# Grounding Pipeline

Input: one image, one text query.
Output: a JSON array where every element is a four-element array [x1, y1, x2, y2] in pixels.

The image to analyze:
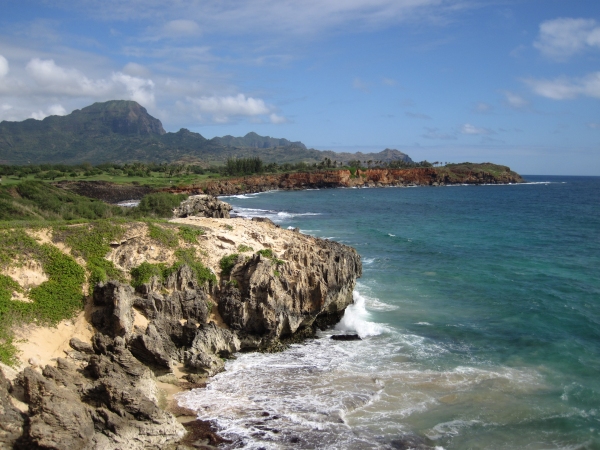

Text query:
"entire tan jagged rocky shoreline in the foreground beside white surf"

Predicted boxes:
[[0, 216, 362, 450]]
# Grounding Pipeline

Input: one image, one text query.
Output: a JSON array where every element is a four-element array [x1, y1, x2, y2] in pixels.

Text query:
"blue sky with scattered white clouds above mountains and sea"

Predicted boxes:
[[0, 0, 600, 176]]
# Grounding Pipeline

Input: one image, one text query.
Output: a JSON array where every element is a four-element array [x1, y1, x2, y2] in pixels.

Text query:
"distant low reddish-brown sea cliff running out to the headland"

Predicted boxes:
[[167, 164, 523, 195]]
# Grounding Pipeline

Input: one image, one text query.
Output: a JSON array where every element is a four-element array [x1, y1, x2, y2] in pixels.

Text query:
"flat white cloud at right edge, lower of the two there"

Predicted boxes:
[[524, 72, 600, 100]]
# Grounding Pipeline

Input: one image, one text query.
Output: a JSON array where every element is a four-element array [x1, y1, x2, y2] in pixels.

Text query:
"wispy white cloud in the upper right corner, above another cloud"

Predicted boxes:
[[533, 17, 600, 61]]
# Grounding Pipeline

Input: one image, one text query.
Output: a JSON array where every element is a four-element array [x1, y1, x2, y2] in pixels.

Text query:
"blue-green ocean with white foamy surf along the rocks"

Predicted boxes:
[[180, 176, 600, 450]]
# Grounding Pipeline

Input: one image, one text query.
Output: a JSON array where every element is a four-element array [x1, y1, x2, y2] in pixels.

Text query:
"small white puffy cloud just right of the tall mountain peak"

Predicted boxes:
[[188, 94, 278, 123]]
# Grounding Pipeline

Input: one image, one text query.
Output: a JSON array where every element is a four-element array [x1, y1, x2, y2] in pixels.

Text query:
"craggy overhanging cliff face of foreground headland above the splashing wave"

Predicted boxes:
[[219, 239, 361, 338]]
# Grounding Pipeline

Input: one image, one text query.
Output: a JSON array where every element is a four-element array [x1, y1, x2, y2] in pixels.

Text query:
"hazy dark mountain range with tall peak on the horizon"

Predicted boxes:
[[0, 100, 410, 165]]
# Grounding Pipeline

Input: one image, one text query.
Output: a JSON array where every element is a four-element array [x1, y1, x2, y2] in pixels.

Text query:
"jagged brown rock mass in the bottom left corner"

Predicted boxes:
[[8, 350, 184, 450]]
